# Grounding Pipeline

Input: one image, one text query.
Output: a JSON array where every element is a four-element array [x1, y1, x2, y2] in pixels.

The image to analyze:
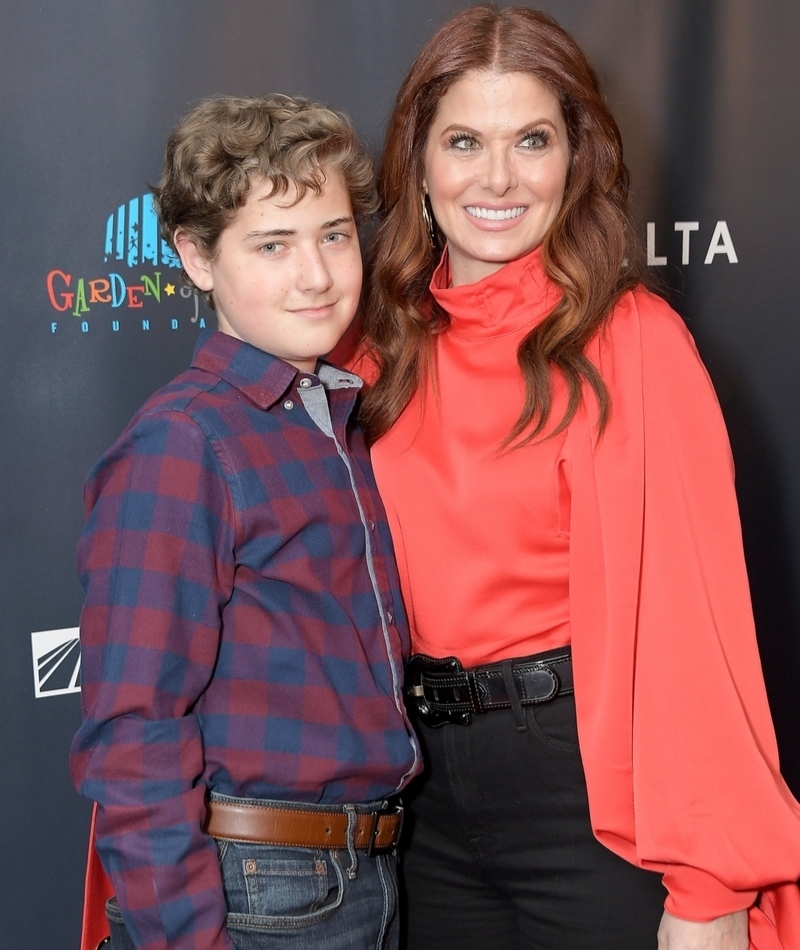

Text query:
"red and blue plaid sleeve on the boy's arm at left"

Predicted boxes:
[[71, 411, 235, 950]]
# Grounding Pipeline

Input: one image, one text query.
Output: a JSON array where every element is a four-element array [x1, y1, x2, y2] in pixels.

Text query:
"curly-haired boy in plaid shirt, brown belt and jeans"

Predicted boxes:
[[72, 96, 419, 950]]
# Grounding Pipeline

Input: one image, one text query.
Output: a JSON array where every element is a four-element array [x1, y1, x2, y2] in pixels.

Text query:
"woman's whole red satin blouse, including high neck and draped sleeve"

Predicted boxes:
[[361, 251, 800, 950]]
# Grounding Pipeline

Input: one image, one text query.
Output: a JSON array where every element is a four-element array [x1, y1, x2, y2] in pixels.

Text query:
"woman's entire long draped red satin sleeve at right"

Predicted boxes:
[[570, 291, 800, 950]]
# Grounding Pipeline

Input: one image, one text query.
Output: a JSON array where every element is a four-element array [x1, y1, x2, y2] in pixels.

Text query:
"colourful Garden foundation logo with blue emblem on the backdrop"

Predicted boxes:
[[45, 194, 206, 334]]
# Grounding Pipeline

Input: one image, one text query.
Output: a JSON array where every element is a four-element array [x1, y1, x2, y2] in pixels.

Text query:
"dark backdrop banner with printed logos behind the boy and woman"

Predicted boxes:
[[0, 0, 800, 950]]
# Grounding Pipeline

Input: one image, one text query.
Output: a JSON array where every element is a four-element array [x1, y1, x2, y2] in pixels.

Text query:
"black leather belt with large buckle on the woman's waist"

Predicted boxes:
[[406, 647, 573, 728]]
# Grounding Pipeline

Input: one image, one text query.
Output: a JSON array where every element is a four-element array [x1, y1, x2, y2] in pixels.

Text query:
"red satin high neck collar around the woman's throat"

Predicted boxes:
[[430, 247, 560, 339]]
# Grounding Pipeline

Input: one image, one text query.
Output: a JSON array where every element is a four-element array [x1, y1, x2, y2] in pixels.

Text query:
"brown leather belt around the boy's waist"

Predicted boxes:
[[205, 800, 403, 855]]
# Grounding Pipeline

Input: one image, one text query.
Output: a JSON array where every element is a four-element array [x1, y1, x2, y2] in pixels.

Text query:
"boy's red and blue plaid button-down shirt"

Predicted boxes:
[[72, 333, 419, 950]]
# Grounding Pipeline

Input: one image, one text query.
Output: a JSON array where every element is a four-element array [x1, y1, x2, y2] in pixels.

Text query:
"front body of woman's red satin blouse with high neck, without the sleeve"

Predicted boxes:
[[373, 254, 571, 666]]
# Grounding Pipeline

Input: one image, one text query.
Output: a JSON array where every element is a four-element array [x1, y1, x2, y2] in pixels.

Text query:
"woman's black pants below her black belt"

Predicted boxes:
[[401, 696, 666, 950]]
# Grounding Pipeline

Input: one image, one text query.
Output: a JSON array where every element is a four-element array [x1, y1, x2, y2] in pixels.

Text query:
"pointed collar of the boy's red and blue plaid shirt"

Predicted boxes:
[[192, 330, 362, 409]]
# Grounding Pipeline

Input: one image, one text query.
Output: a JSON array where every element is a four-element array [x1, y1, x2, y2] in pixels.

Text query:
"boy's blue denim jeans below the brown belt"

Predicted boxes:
[[107, 799, 399, 950]]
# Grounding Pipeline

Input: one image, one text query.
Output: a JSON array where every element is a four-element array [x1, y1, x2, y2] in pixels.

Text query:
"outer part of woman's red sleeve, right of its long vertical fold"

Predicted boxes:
[[633, 295, 800, 920]]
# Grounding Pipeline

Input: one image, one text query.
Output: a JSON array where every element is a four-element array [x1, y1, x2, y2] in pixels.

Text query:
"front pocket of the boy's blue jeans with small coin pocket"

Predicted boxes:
[[221, 842, 344, 930]]
